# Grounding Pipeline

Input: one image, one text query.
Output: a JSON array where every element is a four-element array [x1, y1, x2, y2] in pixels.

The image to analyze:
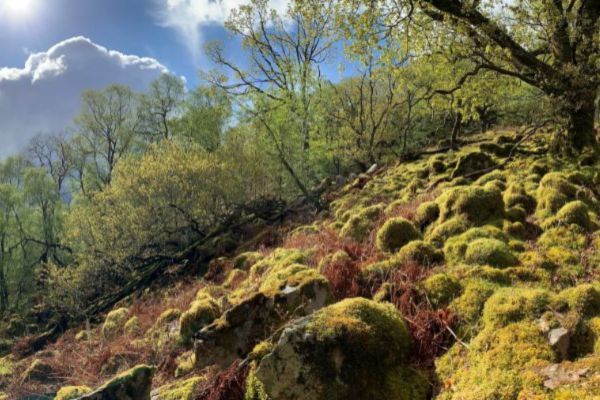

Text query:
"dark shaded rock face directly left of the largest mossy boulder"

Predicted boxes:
[[195, 279, 332, 367]]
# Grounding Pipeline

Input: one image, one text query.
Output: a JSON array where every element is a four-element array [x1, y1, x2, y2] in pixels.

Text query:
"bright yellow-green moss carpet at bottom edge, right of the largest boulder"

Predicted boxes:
[[436, 322, 555, 400]]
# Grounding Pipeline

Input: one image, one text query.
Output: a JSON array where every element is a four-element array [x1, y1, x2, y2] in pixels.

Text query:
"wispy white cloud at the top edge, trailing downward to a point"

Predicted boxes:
[[155, 0, 289, 59]]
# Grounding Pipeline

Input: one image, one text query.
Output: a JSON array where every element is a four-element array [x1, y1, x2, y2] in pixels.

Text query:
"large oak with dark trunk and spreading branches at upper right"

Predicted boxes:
[[349, 0, 600, 152]]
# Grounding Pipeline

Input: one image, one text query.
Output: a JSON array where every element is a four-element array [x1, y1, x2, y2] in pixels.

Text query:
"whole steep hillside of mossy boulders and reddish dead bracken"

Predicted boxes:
[[0, 131, 600, 400]]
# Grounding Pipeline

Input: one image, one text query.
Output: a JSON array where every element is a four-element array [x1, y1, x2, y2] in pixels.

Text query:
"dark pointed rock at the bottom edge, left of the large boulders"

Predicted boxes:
[[79, 365, 156, 400]]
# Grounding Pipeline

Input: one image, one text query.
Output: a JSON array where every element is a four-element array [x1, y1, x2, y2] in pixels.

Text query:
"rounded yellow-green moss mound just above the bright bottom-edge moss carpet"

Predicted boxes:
[[483, 288, 551, 329]]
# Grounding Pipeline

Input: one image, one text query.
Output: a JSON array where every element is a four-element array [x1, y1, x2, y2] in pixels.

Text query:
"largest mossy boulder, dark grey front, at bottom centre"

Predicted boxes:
[[255, 298, 429, 400]]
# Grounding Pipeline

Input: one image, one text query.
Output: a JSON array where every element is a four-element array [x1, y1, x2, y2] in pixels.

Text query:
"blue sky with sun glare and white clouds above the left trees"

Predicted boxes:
[[0, 0, 286, 158]]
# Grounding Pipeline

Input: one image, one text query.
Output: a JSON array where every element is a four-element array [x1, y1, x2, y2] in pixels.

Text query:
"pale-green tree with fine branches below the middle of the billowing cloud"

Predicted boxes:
[[75, 85, 139, 185]]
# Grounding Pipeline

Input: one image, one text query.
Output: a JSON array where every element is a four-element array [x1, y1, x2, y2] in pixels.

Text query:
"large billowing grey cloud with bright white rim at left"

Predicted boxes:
[[0, 37, 168, 157]]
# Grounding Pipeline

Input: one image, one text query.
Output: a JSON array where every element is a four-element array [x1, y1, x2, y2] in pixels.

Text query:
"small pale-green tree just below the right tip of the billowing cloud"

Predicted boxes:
[[139, 74, 185, 141]]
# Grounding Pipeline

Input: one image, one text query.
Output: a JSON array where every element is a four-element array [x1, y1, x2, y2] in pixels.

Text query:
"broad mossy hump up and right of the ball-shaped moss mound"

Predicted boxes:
[[437, 186, 504, 225]]
